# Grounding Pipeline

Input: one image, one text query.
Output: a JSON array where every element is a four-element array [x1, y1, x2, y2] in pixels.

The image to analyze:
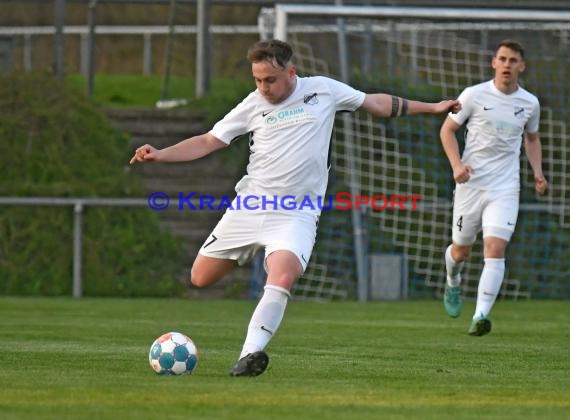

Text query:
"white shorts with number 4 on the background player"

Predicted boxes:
[[452, 184, 519, 246]]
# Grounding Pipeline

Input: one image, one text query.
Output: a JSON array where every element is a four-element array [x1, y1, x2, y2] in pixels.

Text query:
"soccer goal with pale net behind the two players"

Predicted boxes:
[[259, 6, 570, 300]]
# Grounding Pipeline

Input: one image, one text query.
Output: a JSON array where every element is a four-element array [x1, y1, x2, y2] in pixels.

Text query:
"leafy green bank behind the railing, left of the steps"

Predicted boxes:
[[0, 74, 185, 296]]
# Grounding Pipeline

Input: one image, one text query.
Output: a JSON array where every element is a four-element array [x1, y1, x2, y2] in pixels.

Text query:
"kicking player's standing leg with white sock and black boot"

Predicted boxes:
[[230, 251, 303, 376]]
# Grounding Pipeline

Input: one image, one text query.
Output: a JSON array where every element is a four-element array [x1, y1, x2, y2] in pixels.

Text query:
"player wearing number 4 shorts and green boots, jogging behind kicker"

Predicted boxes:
[[440, 40, 547, 336]]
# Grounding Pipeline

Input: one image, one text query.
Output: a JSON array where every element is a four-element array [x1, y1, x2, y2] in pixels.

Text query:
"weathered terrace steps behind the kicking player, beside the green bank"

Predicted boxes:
[[106, 109, 251, 298]]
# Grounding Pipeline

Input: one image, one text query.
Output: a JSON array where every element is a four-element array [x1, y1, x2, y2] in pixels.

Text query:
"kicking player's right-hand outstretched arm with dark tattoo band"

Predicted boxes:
[[362, 93, 461, 118]]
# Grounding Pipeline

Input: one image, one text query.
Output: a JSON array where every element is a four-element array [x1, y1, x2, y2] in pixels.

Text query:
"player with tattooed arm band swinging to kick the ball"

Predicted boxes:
[[131, 40, 460, 376]]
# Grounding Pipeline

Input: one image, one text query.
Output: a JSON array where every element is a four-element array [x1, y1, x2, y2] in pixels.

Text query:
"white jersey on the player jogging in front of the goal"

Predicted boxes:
[[449, 80, 540, 191]]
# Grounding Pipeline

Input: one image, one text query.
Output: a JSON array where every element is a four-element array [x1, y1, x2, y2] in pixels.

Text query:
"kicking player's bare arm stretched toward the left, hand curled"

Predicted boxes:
[[130, 133, 227, 165]]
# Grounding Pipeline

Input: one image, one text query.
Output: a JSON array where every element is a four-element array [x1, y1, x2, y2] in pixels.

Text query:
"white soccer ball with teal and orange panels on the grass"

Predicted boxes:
[[148, 332, 198, 375]]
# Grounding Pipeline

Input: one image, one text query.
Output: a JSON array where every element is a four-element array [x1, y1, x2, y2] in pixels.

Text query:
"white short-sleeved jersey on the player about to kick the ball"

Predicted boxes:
[[210, 76, 365, 203]]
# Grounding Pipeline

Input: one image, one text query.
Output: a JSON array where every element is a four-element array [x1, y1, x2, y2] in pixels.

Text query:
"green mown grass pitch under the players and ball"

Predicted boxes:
[[0, 297, 570, 420]]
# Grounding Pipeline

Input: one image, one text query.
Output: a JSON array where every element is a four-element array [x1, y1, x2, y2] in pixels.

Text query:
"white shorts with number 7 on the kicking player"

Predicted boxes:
[[199, 205, 318, 271]]
